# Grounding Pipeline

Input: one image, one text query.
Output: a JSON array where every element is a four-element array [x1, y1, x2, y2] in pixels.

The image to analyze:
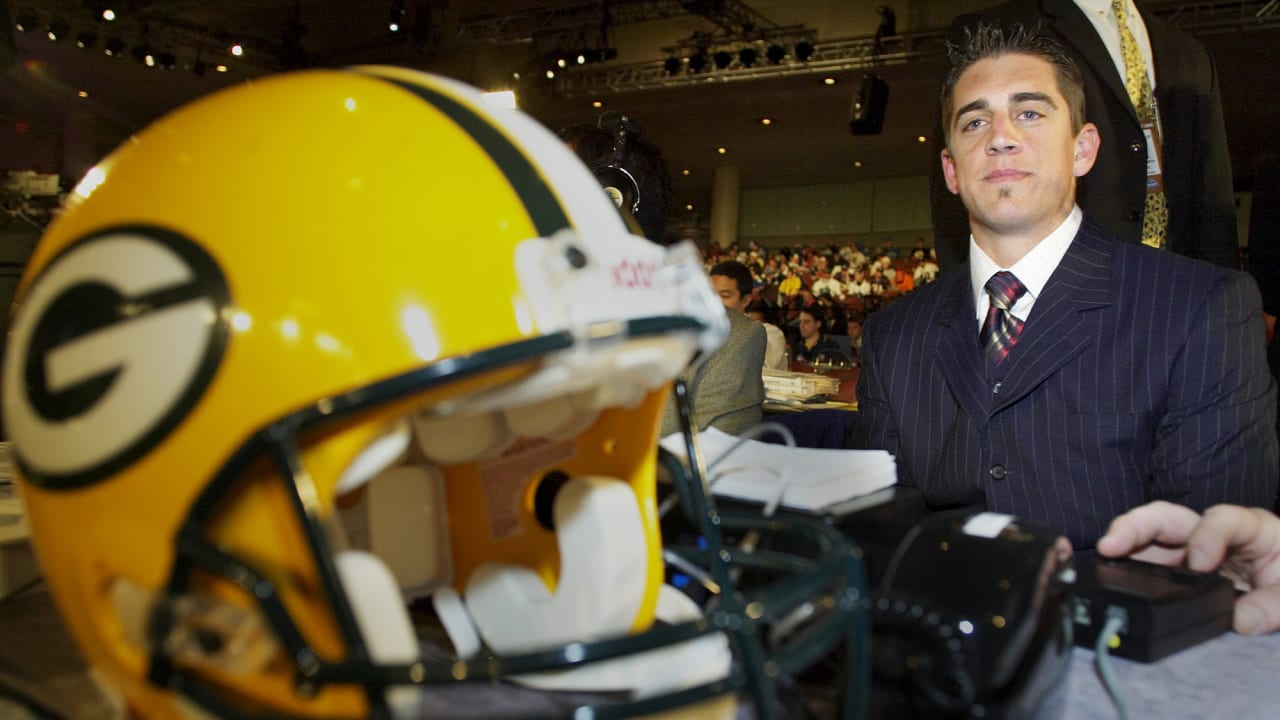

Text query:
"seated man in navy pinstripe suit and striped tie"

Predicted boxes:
[[852, 27, 1280, 551]]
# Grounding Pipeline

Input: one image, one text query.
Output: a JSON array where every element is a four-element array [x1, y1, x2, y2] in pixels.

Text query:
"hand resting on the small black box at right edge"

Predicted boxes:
[[1098, 501, 1280, 635]]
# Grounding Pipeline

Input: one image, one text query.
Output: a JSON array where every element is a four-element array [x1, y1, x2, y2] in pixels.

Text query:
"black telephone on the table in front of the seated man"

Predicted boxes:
[[872, 512, 1074, 717]]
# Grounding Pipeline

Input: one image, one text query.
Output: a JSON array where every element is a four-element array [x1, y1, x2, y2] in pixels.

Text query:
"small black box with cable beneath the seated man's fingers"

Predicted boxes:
[[1075, 559, 1235, 662]]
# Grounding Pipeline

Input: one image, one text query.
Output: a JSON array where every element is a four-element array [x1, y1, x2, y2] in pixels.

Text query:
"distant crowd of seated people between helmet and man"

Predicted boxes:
[[704, 238, 938, 366]]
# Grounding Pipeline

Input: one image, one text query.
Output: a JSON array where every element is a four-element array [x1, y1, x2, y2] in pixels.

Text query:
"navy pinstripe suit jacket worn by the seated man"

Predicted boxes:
[[852, 220, 1280, 551]]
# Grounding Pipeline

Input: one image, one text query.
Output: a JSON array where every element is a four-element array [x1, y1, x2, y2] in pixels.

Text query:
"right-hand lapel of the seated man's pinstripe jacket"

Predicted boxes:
[[991, 222, 1112, 413]]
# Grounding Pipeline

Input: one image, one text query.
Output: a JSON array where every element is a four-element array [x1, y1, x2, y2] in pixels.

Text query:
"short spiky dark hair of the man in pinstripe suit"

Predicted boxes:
[[942, 20, 1084, 147]]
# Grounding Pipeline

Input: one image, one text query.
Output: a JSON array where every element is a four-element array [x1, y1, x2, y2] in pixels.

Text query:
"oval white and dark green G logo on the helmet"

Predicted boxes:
[[3, 225, 230, 488]]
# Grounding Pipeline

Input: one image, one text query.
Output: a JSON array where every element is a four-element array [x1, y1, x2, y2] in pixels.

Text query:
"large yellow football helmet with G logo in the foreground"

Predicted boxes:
[[3, 67, 856, 717]]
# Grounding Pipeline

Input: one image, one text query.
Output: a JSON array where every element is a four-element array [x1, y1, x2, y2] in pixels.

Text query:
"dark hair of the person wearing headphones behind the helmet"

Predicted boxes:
[[559, 123, 672, 245]]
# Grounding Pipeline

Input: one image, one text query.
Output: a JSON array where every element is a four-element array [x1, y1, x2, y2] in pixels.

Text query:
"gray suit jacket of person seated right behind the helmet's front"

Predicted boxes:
[[662, 309, 765, 437]]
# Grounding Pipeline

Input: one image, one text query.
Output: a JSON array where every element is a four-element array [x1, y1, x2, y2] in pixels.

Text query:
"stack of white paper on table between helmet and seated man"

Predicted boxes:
[[662, 428, 897, 510]]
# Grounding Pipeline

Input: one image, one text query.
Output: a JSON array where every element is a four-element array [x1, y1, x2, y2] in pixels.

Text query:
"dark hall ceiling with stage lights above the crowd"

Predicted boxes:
[[0, 0, 1280, 222]]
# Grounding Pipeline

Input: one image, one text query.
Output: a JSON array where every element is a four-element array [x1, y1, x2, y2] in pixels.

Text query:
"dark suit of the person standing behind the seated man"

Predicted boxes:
[[931, 0, 1240, 270]]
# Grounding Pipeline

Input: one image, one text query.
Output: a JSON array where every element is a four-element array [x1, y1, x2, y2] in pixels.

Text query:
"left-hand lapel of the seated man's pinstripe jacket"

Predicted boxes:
[[931, 269, 988, 427]]
